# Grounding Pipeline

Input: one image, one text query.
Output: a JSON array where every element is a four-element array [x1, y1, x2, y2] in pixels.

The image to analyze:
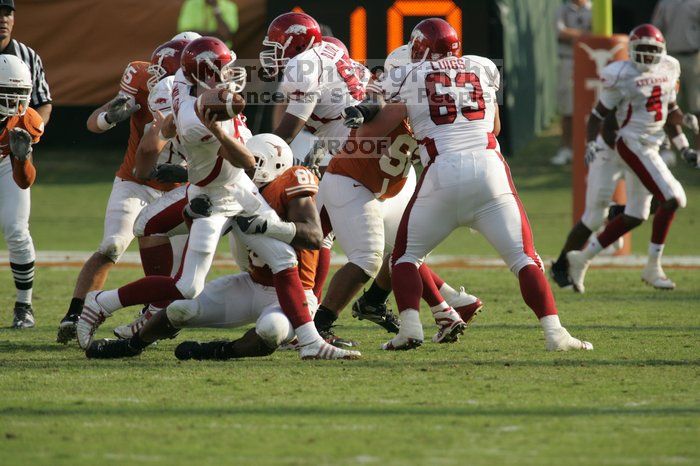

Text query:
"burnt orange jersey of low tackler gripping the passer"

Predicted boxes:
[[250, 166, 318, 290]]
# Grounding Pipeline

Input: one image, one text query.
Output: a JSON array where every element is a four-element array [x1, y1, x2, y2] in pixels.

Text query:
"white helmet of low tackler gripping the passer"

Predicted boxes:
[[246, 133, 294, 186]]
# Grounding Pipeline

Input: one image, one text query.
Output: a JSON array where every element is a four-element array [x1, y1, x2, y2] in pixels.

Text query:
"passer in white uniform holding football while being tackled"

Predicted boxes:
[[77, 37, 356, 359]]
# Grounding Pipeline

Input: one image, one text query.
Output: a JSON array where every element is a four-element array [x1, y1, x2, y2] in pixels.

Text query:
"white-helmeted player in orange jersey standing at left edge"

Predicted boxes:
[[0, 55, 44, 329]]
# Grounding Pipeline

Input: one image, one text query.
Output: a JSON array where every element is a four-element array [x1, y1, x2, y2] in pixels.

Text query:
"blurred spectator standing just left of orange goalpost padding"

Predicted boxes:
[[551, 0, 591, 165]]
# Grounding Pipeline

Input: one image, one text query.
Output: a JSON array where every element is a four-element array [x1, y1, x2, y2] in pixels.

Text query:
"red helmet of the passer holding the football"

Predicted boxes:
[[180, 37, 246, 93]]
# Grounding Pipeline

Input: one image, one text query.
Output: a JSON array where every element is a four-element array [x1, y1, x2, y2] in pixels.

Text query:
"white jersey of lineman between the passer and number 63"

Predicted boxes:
[[281, 42, 369, 153]]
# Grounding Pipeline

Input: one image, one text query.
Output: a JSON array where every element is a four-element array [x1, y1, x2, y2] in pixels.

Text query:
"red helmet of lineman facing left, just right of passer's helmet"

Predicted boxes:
[[260, 13, 321, 76]]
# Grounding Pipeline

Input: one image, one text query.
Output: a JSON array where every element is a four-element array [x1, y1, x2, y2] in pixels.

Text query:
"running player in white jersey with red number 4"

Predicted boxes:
[[566, 24, 698, 293]]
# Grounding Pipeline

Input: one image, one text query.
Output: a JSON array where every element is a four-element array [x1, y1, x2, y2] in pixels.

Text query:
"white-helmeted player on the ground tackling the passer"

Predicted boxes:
[[86, 134, 359, 360]]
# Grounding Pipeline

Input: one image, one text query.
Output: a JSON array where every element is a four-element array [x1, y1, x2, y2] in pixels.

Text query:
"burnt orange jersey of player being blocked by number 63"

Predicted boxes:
[[326, 121, 418, 199]]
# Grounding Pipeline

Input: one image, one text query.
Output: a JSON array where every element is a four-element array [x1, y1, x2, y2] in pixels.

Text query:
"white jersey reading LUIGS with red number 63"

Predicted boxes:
[[381, 55, 500, 165]]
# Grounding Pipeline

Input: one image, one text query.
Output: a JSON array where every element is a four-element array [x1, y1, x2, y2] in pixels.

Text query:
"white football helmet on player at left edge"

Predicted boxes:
[[0, 55, 32, 120]]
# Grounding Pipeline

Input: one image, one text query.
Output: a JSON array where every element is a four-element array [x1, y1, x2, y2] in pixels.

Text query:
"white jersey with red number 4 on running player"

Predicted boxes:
[[600, 55, 681, 146]]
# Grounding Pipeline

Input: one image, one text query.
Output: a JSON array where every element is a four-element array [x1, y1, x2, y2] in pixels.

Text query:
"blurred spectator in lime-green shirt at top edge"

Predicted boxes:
[[177, 0, 238, 47]]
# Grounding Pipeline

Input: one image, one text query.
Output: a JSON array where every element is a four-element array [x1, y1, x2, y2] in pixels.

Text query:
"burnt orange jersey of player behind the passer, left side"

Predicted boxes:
[[117, 61, 177, 191]]
